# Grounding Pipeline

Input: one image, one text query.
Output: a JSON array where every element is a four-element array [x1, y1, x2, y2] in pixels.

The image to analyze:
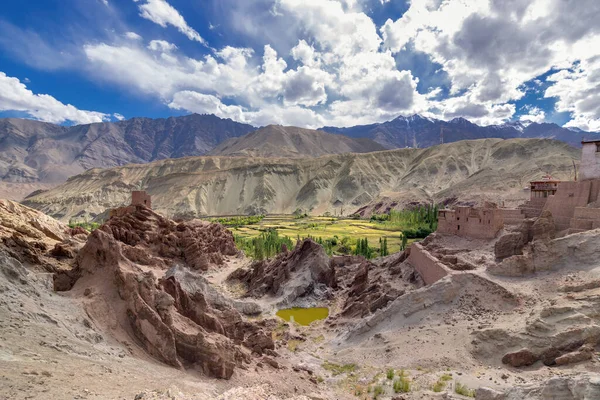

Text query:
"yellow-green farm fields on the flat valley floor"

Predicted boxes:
[[220, 215, 414, 253]]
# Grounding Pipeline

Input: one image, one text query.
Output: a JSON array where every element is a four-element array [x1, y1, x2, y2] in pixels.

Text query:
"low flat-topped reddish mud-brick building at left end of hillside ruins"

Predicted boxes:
[[437, 206, 504, 239]]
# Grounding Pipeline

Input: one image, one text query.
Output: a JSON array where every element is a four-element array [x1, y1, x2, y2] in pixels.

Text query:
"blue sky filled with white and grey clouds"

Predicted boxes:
[[0, 0, 600, 130]]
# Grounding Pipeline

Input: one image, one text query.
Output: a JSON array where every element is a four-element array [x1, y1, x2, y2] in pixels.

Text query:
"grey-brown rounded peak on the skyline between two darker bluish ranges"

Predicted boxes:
[[209, 125, 385, 157]]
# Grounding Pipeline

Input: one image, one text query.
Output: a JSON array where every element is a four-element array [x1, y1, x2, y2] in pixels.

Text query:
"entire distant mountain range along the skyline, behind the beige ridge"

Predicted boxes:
[[0, 114, 600, 199]]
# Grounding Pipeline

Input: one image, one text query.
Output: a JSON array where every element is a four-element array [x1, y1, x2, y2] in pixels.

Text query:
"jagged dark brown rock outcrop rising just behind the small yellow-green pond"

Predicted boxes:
[[228, 239, 337, 305]]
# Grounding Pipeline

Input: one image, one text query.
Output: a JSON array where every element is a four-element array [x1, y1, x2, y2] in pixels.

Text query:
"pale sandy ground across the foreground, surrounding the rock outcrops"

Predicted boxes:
[[0, 231, 600, 400]]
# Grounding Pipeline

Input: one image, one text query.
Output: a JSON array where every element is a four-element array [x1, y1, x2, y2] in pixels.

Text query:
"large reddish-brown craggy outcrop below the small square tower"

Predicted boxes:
[[73, 207, 274, 379]]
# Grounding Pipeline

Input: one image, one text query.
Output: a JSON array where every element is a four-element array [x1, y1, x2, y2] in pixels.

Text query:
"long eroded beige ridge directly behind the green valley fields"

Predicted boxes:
[[24, 139, 579, 221]]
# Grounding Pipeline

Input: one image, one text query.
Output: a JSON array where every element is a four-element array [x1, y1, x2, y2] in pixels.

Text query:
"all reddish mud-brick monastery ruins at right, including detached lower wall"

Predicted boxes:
[[408, 140, 600, 285]]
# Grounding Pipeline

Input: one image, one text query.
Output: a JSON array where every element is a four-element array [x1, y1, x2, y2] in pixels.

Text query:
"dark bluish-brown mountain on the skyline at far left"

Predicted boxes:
[[0, 114, 255, 198]]
